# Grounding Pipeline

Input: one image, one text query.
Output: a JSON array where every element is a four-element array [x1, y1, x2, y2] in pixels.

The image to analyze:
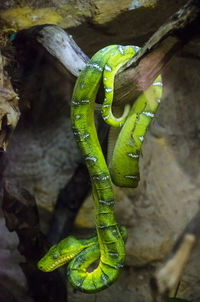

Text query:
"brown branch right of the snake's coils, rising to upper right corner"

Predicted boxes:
[[115, 0, 200, 103]]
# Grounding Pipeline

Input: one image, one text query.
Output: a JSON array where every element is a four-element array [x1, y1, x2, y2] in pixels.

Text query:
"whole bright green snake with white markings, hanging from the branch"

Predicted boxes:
[[38, 45, 162, 293]]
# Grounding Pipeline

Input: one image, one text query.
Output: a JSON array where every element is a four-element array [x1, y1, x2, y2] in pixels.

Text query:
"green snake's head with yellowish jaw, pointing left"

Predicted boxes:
[[37, 236, 84, 272]]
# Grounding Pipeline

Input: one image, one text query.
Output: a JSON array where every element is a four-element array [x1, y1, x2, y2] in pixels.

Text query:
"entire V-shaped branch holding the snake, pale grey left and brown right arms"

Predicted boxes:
[[13, 0, 200, 104]]
